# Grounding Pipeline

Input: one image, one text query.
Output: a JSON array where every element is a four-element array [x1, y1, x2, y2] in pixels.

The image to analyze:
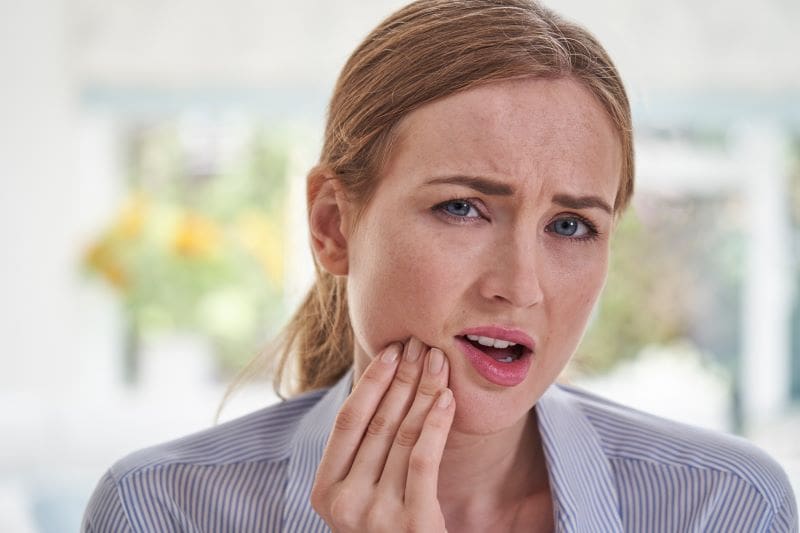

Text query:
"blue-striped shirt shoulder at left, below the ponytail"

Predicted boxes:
[[83, 389, 327, 531]]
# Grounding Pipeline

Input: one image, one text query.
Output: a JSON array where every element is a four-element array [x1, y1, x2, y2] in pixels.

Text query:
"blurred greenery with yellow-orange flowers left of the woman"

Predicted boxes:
[[84, 122, 296, 376]]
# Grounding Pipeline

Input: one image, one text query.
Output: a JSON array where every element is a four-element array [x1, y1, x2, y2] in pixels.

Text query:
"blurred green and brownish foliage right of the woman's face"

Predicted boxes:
[[575, 194, 744, 373]]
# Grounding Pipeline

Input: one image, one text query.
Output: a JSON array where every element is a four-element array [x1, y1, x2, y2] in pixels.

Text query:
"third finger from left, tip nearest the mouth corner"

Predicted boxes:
[[379, 348, 449, 499]]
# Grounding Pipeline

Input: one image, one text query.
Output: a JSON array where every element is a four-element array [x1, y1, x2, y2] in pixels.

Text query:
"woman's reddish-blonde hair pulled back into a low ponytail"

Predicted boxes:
[[234, 0, 633, 400]]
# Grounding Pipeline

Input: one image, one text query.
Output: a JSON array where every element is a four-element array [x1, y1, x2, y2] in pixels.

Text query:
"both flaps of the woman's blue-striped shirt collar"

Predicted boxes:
[[284, 370, 623, 533]]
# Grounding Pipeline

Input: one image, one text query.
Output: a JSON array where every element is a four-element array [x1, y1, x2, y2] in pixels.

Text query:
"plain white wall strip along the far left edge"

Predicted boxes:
[[0, 0, 79, 390]]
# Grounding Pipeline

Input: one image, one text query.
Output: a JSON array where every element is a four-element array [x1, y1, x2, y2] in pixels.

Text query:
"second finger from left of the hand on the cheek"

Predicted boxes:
[[348, 337, 427, 484]]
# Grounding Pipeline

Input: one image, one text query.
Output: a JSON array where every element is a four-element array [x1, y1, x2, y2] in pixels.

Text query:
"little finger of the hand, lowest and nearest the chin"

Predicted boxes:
[[405, 389, 456, 513]]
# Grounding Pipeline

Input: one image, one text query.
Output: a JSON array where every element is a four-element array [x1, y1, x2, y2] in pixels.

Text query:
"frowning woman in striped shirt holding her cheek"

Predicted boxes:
[[84, 0, 797, 532]]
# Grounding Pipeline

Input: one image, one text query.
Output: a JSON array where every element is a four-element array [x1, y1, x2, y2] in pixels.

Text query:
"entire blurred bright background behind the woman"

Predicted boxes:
[[0, 0, 800, 532]]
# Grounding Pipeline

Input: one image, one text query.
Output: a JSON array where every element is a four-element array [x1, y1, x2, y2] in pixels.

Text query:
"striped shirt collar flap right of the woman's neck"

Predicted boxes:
[[536, 385, 623, 533]]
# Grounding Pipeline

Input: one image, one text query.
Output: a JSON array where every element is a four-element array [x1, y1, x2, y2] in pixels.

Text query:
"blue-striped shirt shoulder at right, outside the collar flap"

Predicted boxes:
[[560, 386, 797, 530]]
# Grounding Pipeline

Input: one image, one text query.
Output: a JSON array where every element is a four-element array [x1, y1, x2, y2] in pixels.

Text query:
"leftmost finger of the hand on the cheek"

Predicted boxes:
[[315, 343, 402, 486]]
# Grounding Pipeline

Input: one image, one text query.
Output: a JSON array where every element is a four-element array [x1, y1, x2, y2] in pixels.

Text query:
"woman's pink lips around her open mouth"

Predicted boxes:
[[456, 326, 535, 387]]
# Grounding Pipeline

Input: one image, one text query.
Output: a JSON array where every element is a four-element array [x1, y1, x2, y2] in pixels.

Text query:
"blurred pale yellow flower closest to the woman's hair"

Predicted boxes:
[[236, 211, 283, 286]]
